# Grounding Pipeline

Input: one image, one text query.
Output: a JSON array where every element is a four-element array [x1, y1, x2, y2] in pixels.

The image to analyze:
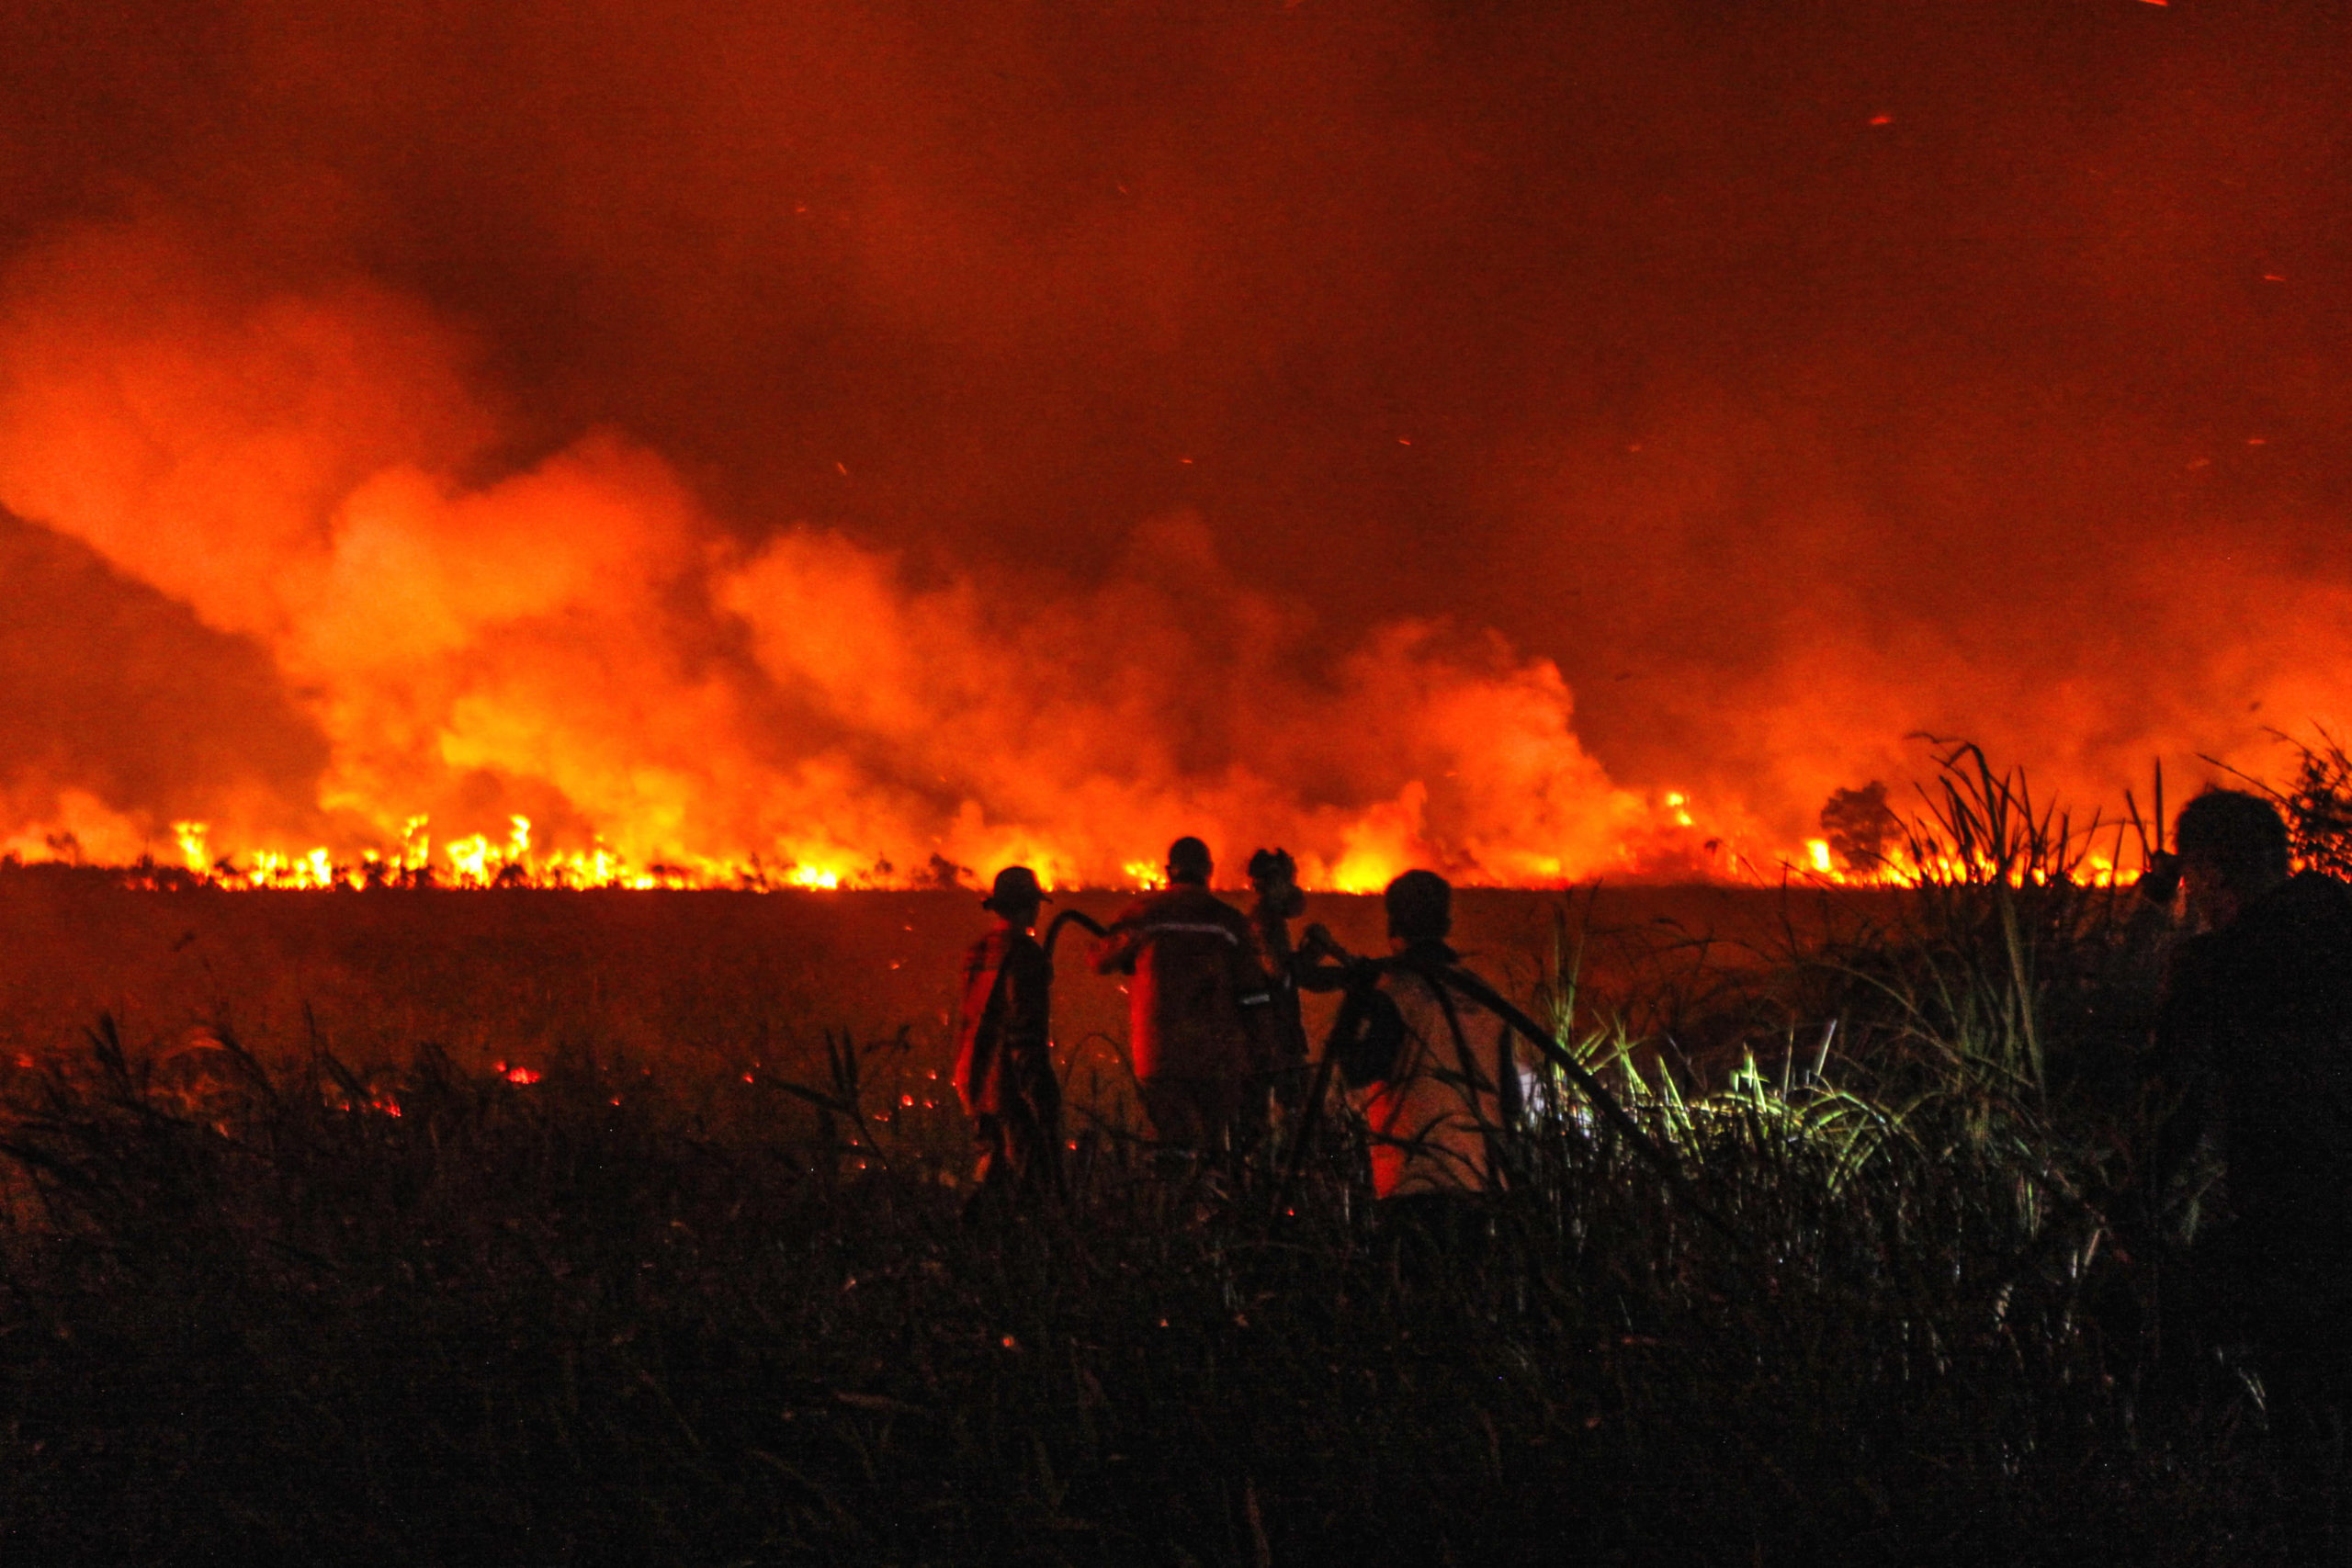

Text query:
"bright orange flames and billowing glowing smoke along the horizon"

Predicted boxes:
[[0, 231, 2352, 891]]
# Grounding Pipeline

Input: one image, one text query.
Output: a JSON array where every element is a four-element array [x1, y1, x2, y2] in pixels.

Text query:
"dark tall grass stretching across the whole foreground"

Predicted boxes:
[[0, 752, 2314, 1565]]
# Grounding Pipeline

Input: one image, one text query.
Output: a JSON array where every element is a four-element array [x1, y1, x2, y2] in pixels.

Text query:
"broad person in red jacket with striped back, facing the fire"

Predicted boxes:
[[1093, 837, 1275, 1149]]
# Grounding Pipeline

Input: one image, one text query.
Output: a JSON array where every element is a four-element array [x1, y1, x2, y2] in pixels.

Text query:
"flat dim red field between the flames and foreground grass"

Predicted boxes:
[[0, 867, 1871, 1072]]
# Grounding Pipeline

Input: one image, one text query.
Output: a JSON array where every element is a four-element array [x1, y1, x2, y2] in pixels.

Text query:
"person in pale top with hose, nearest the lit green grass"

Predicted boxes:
[[1312, 870, 1521, 1256]]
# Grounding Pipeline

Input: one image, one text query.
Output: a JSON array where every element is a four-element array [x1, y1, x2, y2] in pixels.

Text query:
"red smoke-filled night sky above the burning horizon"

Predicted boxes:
[[0, 0, 2352, 886]]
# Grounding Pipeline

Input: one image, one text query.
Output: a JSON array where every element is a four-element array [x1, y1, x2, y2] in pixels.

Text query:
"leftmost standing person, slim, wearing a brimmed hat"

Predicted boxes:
[[955, 865, 1061, 1213]]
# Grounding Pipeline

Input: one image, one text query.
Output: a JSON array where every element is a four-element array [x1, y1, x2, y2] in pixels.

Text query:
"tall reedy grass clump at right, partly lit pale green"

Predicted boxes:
[[1538, 745, 2211, 1476]]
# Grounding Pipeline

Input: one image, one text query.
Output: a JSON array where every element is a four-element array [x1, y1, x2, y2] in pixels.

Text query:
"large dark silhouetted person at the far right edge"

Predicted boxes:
[[2154, 790, 2352, 1556]]
